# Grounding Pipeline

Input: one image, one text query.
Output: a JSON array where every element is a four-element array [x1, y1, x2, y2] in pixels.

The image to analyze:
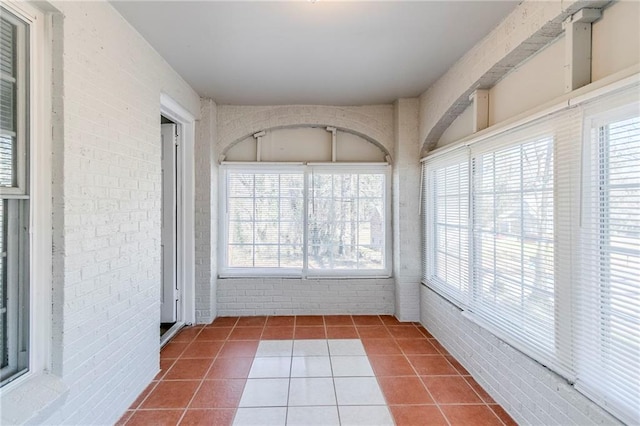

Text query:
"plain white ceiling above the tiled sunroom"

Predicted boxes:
[[112, 0, 518, 105]]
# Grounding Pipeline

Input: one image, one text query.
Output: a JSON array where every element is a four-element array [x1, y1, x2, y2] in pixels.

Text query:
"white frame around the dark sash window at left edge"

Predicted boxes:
[[0, 2, 52, 392]]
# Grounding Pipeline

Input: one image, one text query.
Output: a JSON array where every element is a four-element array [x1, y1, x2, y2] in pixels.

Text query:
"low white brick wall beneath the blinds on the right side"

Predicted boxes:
[[421, 286, 619, 426]]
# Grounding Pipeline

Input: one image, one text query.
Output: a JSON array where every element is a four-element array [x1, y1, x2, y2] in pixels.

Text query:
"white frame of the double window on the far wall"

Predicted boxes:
[[219, 162, 392, 278]]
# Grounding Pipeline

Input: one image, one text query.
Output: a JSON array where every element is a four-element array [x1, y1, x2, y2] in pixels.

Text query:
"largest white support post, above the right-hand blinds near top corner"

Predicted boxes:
[[562, 8, 602, 93]]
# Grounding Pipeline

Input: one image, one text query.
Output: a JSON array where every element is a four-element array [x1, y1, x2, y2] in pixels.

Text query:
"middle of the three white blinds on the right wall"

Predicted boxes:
[[469, 109, 581, 368]]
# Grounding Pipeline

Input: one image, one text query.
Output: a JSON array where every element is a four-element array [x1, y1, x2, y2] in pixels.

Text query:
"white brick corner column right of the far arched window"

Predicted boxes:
[[393, 98, 422, 321]]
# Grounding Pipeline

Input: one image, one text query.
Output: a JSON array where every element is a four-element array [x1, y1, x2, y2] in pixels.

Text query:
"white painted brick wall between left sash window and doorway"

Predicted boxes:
[[45, 2, 200, 424]]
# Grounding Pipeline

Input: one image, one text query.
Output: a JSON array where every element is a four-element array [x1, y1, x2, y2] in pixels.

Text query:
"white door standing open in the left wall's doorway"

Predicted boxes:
[[160, 124, 178, 323]]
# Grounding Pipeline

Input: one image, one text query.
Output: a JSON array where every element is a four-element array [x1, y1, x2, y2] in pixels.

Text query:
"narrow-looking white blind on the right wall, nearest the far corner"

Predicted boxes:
[[423, 148, 470, 305]]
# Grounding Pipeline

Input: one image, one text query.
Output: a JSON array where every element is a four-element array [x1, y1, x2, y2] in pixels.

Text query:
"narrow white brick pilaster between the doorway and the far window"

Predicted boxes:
[[195, 99, 218, 324]]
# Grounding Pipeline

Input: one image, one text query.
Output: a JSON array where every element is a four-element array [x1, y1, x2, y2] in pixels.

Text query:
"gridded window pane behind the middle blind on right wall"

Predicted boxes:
[[473, 138, 555, 352]]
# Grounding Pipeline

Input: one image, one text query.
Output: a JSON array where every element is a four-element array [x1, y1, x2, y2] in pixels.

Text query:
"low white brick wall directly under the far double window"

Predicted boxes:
[[218, 278, 395, 317]]
